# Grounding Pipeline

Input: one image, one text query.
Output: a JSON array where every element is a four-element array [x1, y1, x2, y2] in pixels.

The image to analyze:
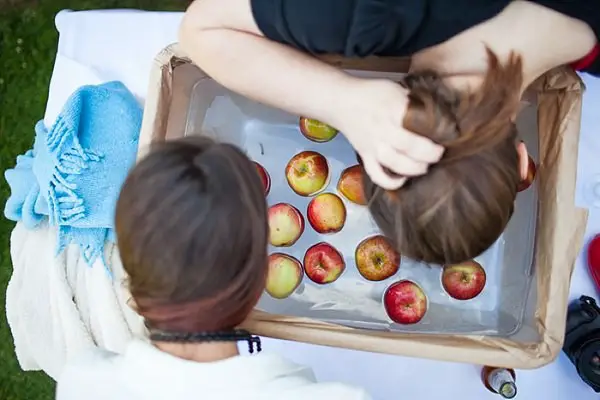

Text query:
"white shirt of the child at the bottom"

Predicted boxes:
[[56, 340, 371, 400]]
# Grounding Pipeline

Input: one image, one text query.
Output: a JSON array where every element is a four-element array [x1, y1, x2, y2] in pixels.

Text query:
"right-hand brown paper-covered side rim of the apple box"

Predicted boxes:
[[532, 68, 588, 363]]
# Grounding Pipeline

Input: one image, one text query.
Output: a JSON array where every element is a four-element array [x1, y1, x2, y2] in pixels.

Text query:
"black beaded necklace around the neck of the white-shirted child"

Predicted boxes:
[[150, 329, 262, 354]]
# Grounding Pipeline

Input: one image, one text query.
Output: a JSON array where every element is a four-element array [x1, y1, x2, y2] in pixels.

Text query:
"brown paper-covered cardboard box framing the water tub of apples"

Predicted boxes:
[[139, 44, 587, 369]]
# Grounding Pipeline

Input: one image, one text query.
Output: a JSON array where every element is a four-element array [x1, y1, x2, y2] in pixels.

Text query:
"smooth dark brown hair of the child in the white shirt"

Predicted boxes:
[[116, 136, 268, 333]]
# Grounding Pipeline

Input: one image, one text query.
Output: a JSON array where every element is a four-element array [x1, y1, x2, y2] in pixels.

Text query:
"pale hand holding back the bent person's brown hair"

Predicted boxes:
[[331, 79, 444, 190]]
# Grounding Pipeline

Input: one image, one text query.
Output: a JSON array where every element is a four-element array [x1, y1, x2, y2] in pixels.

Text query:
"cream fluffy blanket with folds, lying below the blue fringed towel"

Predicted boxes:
[[6, 223, 145, 379]]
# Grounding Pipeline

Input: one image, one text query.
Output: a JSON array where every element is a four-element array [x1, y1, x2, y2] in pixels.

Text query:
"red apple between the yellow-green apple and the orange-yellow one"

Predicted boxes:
[[304, 242, 346, 285]]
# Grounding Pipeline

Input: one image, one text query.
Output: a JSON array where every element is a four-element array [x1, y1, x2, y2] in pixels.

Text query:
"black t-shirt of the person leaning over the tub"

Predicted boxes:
[[251, 0, 600, 76]]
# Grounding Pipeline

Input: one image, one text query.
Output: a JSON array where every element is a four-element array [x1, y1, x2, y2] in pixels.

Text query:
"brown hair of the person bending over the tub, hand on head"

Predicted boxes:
[[365, 50, 523, 265]]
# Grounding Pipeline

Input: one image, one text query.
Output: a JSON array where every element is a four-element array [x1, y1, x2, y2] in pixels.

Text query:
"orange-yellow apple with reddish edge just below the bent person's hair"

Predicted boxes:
[[354, 235, 400, 281]]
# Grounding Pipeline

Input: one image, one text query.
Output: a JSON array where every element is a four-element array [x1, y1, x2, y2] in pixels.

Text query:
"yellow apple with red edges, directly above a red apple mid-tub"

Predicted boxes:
[[306, 193, 346, 233]]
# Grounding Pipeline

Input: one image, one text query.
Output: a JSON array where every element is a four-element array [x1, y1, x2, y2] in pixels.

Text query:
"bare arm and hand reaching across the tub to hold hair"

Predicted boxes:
[[179, 0, 443, 189]]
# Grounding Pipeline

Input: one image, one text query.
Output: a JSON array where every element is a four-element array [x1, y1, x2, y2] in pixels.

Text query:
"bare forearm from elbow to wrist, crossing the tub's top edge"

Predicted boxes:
[[180, 1, 358, 126]]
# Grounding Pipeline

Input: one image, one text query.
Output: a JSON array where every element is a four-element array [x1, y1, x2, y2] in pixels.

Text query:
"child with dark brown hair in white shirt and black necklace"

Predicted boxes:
[[57, 137, 370, 400]]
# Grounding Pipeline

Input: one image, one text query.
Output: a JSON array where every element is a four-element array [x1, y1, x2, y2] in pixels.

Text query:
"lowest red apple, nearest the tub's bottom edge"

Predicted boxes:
[[383, 280, 427, 325]]
